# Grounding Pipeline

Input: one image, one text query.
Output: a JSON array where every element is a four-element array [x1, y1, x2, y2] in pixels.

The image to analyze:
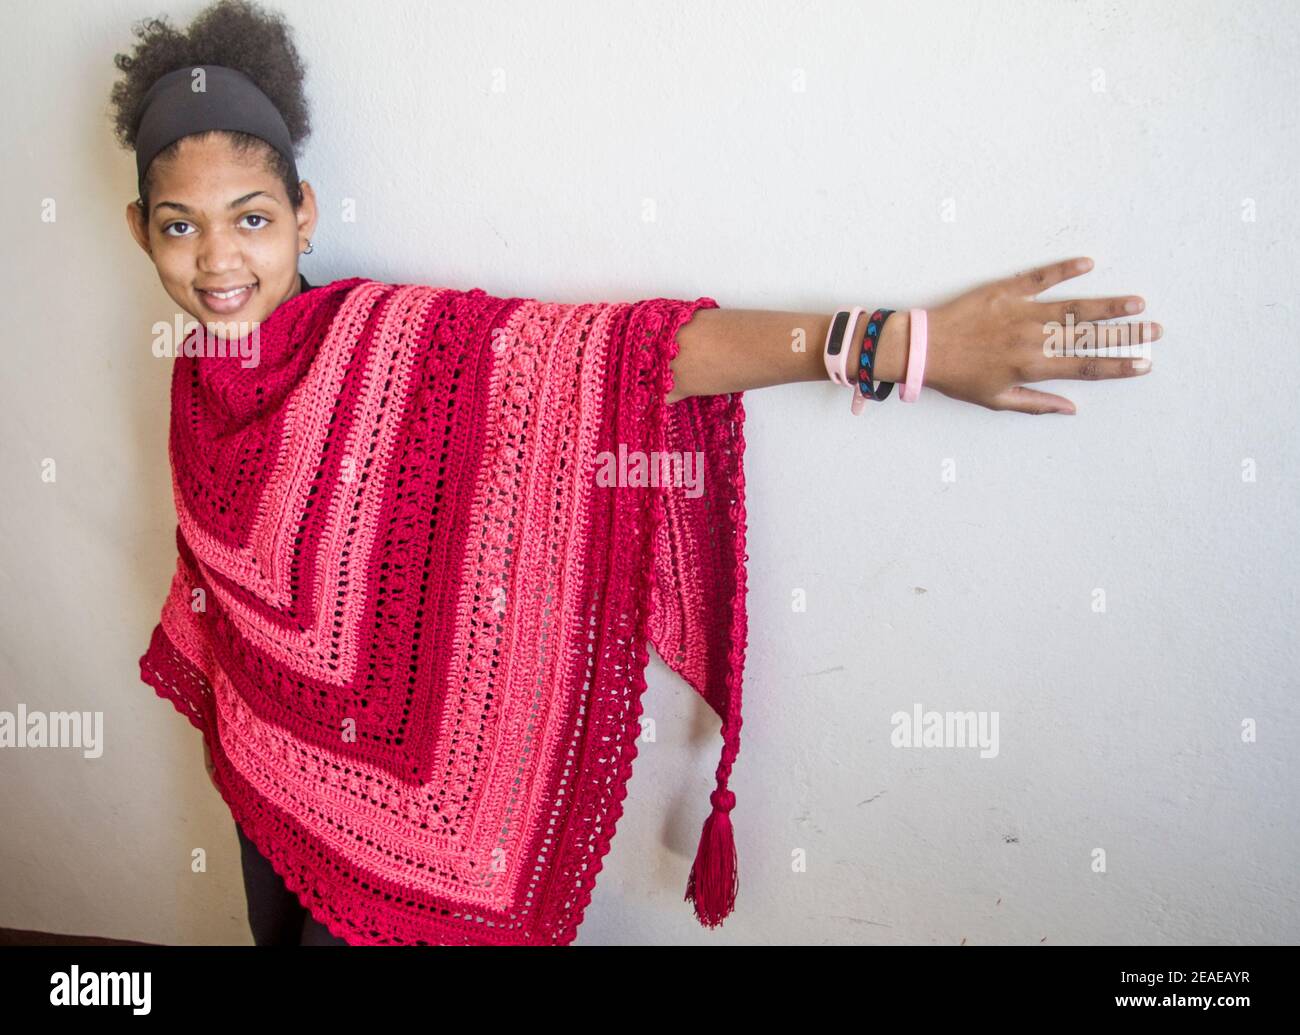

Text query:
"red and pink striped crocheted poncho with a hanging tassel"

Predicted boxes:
[[140, 277, 748, 945]]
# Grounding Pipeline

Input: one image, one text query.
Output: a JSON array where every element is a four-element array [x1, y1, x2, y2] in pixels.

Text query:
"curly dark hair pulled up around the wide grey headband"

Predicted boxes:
[[111, 0, 312, 218]]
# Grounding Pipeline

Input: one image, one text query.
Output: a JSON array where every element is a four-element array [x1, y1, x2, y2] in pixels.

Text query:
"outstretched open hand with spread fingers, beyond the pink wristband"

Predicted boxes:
[[915, 257, 1164, 413]]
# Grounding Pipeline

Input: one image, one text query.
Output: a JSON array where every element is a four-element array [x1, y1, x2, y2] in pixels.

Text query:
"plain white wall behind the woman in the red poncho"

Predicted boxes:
[[0, 0, 1300, 944]]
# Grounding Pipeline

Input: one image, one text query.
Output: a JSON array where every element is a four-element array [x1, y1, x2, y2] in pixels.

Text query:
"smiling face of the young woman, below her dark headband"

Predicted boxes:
[[126, 133, 316, 337]]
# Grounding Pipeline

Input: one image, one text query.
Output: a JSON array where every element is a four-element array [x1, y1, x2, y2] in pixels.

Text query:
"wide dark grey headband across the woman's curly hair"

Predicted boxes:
[[135, 65, 298, 198]]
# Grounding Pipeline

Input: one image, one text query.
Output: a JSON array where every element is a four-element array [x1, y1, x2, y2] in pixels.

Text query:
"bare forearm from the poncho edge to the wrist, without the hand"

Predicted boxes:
[[668, 309, 907, 403]]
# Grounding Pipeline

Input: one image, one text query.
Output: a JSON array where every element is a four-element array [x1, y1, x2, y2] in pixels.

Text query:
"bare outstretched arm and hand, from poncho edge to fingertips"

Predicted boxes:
[[667, 259, 1162, 413]]
